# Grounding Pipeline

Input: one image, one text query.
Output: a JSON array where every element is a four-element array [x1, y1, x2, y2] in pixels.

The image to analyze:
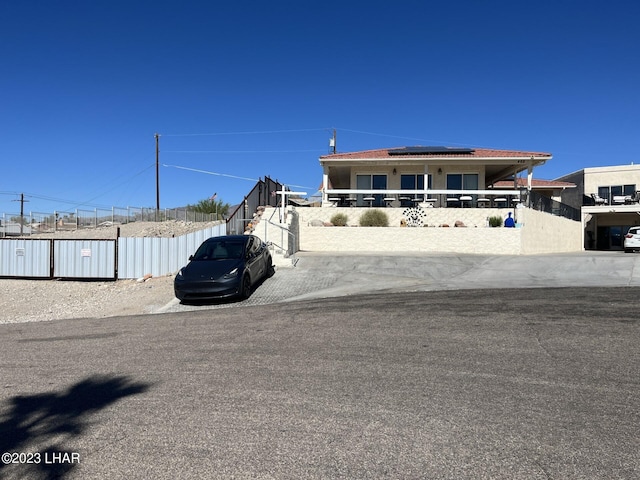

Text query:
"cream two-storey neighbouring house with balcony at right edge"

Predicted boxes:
[[556, 164, 640, 250]]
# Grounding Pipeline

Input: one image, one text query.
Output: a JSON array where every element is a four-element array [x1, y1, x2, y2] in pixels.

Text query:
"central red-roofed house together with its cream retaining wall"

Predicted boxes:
[[251, 146, 583, 255]]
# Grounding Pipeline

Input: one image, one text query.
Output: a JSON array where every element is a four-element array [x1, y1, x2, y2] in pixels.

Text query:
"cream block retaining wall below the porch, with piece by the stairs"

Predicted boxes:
[[254, 208, 582, 255]]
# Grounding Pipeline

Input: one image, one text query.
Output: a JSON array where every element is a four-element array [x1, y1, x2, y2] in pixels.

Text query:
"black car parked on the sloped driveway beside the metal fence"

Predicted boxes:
[[173, 235, 274, 302]]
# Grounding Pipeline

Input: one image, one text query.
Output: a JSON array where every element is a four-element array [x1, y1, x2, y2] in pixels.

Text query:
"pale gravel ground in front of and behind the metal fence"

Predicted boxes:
[[0, 221, 215, 323]]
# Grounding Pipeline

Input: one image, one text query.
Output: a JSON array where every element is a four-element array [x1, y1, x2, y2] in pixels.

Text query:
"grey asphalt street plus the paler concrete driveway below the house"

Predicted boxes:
[[0, 254, 640, 479]]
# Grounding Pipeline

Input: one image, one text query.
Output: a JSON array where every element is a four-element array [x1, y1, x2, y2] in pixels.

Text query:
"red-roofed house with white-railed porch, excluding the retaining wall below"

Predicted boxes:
[[320, 146, 552, 208]]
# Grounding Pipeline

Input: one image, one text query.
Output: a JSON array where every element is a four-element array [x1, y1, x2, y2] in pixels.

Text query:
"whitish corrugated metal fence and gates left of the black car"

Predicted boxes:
[[0, 224, 226, 280]]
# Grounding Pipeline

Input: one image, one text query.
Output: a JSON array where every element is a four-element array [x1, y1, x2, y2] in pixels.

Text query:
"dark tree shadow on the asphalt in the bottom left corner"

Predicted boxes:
[[0, 375, 151, 479]]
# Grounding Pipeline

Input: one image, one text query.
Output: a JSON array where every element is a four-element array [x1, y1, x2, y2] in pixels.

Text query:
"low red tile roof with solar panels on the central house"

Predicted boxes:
[[320, 147, 551, 161]]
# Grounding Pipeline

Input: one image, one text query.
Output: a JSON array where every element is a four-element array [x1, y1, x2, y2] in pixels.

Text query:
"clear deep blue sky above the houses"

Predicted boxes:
[[0, 0, 640, 213]]
